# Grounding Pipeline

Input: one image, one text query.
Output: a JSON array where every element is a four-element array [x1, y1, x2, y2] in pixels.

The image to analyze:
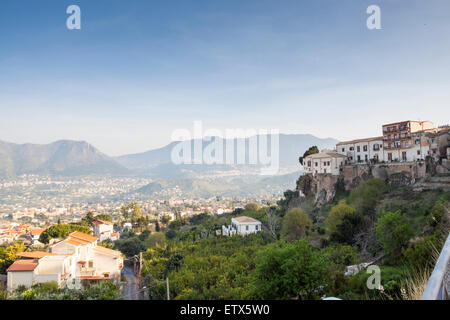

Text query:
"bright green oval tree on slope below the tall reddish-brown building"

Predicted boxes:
[[375, 211, 414, 259]]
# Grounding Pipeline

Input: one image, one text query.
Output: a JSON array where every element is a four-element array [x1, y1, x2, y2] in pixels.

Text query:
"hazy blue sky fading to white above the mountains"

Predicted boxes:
[[0, 0, 450, 155]]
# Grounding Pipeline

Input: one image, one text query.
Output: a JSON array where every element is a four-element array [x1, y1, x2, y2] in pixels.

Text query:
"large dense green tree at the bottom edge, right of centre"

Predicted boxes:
[[254, 239, 329, 300]]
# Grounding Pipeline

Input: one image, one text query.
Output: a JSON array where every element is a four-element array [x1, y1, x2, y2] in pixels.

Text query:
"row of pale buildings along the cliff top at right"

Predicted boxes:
[[303, 121, 450, 175]]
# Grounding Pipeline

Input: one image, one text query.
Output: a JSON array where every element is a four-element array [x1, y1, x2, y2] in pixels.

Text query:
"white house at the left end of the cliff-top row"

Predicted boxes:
[[303, 150, 347, 175]]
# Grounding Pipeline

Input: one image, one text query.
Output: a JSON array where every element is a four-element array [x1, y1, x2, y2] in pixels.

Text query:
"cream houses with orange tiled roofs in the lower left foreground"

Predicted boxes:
[[7, 231, 123, 290]]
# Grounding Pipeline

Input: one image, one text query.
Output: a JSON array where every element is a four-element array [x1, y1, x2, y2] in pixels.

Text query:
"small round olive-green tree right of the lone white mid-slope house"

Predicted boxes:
[[281, 208, 313, 241]]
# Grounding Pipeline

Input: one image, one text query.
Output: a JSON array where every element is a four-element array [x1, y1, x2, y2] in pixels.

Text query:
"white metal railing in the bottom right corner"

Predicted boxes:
[[422, 235, 450, 300]]
